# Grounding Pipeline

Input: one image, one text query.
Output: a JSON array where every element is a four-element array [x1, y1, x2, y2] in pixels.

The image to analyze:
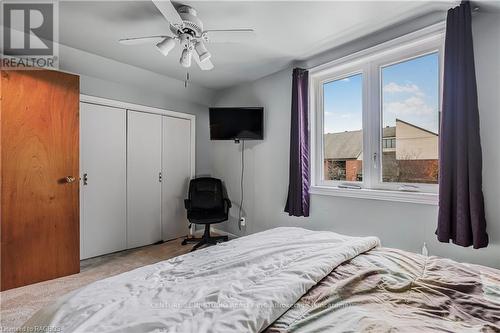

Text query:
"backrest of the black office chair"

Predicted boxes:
[[189, 177, 224, 210]]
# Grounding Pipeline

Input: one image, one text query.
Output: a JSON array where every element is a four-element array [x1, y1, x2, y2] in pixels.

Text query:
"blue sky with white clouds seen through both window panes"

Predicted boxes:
[[323, 53, 439, 133]]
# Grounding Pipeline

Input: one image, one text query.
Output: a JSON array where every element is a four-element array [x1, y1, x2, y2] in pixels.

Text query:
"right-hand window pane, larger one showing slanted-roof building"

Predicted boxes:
[[382, 53, 439, 184]]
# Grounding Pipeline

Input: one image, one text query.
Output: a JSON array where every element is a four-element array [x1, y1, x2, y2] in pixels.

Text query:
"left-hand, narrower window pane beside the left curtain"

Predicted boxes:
[[323, 74, 363, 181]]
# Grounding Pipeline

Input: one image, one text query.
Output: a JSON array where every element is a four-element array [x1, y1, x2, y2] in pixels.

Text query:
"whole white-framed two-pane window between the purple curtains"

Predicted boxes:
[[310, 30, 443, 204]]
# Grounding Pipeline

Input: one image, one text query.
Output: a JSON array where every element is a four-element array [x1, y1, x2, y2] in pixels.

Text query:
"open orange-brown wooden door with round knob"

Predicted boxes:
[[0, 70, 80, 290]]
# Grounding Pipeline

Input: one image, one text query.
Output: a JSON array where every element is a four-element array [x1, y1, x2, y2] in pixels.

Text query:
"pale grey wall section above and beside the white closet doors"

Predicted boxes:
[[59, 45, 215, 175]]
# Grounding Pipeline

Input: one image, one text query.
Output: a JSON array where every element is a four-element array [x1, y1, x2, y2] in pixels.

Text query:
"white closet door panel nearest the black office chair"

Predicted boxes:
[[162, 117, 192, 240]]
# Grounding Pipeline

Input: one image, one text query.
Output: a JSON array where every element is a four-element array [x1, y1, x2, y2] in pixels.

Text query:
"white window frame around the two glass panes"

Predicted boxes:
[[309, 24, 444, 205]]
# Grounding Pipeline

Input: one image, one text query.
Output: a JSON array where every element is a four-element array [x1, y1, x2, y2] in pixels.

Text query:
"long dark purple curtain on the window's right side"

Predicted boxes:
[[436, 2, 488, 249]]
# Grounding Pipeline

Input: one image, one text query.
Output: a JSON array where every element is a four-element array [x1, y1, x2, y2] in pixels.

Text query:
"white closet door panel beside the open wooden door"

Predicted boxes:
[[80, 103, 127, 259]]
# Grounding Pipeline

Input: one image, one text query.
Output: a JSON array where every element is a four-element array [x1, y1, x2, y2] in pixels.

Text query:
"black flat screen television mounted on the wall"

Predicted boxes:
[[210, 107, 264, 140]]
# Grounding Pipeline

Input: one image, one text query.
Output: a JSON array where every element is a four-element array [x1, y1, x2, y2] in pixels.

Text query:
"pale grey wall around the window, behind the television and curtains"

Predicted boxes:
[[211, 12, 500, 268]]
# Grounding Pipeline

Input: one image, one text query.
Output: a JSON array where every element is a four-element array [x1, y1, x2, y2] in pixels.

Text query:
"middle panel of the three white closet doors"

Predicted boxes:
[[127, 111, 162, 248]]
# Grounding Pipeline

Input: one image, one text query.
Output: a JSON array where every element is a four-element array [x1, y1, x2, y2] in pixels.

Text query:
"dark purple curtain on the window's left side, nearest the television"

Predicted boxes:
[[285, 68, 309, 216]]
